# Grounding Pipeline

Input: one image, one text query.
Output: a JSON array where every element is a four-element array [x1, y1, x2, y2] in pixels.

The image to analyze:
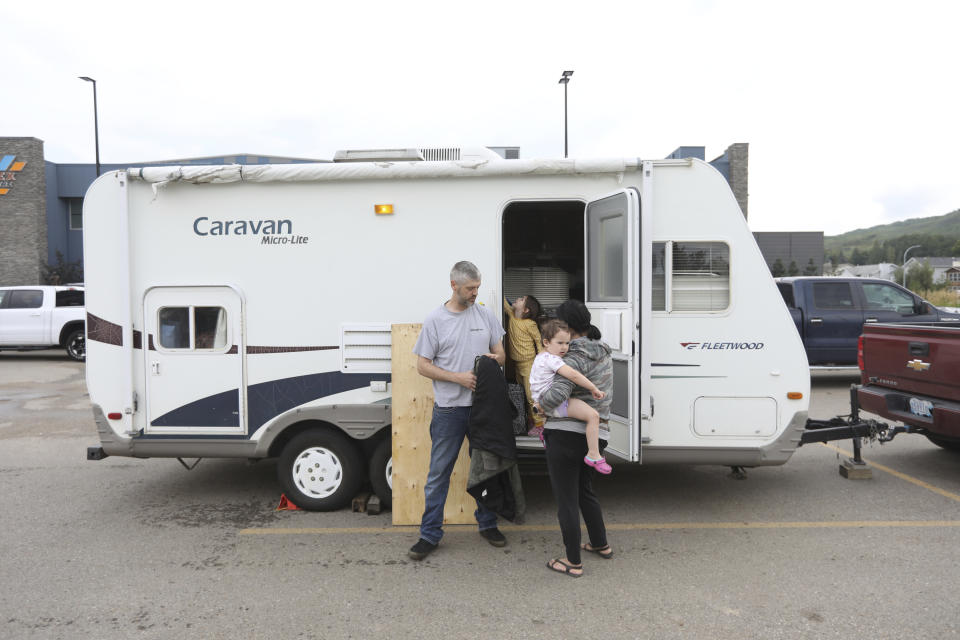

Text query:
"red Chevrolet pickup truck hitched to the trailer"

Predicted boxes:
[[857, 324, 960, 451]]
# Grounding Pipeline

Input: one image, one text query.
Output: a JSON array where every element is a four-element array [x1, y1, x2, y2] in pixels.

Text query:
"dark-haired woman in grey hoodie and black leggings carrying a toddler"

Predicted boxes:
[[539, 300, 613, 578]]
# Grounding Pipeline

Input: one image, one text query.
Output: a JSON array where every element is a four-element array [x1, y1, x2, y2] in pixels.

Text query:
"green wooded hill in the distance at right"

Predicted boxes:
[[823, 209, 960, 264]]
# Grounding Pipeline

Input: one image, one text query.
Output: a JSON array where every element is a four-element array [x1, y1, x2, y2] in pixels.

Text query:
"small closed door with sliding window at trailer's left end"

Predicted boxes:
[[143, 286, 246, 435]]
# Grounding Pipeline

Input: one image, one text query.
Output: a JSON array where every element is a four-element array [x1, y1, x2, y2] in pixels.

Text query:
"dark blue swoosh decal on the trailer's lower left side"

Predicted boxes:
[[143, 371, 391, 438]]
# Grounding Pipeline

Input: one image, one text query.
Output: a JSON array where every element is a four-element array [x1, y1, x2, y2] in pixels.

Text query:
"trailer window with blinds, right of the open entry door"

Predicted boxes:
[[652, 241, 730, 312]]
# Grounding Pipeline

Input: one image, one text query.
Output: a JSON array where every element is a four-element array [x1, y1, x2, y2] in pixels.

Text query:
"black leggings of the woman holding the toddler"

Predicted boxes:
[[543, 429, 607, 564]]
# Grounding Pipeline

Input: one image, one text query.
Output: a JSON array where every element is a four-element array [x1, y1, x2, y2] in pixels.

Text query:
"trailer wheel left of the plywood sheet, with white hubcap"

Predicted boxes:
[[277, 429, 363, 511]]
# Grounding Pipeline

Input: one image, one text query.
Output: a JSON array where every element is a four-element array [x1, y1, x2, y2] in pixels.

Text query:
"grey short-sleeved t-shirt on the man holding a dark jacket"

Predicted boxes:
[[413, 304, 504, 407]]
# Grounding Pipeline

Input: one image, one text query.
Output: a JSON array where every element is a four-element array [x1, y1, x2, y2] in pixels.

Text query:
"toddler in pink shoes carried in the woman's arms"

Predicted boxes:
[[530, 319, 613, 475]]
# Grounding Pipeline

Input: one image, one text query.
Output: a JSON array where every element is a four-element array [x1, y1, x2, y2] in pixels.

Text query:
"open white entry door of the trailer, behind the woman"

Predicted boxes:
[[585, 189, 641, 461]]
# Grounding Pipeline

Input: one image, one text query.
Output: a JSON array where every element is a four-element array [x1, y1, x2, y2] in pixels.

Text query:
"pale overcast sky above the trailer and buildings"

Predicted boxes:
[[7, 0, 960, 235]]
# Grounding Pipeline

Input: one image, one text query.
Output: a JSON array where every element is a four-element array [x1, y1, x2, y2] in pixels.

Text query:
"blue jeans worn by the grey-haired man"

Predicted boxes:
[[420, 405, 497, 544]]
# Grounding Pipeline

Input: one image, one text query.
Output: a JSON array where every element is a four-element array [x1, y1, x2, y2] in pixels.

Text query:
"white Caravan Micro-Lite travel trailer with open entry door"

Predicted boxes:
[[83, 153, 810, 510]]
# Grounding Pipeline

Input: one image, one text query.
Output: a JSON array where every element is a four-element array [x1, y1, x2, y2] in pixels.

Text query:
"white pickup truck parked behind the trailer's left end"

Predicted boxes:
[[0, 286, 87, 362]]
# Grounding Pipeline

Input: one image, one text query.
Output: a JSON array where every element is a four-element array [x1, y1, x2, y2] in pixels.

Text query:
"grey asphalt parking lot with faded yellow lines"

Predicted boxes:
[[0, 351, 960, 639]]
